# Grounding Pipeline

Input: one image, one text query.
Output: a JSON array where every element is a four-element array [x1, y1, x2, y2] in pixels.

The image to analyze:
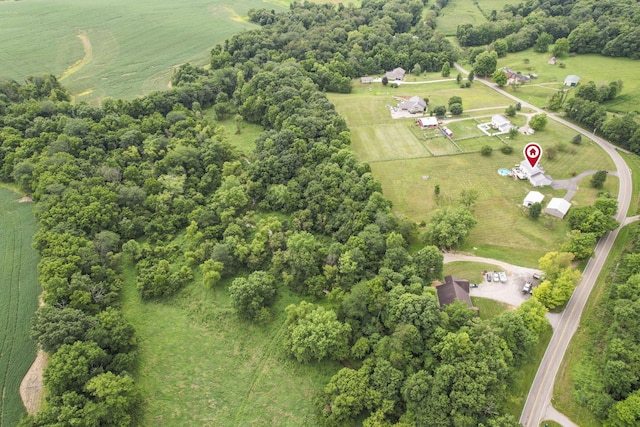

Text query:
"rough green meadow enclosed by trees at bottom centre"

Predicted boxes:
[[123, 261, 341, 426]]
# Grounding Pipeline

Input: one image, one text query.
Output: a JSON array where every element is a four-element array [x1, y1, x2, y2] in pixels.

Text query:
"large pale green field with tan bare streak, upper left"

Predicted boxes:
[[0, 0, 284, 102]]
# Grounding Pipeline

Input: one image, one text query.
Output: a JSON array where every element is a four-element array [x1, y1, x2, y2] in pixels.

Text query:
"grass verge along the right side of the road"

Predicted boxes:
[[553, 223, 638, 427]]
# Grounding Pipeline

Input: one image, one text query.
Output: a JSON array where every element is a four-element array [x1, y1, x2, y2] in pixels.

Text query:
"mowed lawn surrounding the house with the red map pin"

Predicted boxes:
[[329, 82, 618, 267]]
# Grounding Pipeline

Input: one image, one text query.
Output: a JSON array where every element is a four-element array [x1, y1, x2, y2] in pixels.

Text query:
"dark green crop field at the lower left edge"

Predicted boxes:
[[0, 187, 40, 427]]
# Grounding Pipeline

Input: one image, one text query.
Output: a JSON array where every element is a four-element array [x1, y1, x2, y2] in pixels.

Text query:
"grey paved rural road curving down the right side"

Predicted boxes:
[[455, 64, 632, 427]]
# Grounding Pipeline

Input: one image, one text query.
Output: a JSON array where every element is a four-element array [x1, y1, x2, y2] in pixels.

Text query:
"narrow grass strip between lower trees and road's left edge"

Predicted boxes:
[[504, 325, 556, 420]]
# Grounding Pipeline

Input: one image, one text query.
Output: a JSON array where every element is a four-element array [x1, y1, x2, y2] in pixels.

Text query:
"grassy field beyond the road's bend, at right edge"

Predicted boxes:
[[498, 49, 640, 112]]
